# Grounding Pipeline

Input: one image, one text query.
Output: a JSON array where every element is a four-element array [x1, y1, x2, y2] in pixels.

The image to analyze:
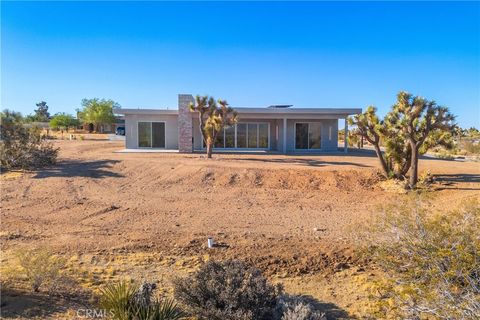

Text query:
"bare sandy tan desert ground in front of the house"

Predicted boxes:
[[0, 140, 480, 319]]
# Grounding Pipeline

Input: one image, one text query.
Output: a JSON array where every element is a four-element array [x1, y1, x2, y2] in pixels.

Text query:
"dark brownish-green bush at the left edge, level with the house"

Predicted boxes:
[[0, 110, 58, 169]]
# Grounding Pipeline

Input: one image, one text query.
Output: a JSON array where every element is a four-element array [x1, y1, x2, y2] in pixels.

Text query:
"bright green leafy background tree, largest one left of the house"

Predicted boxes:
[[78, 98, 120, 132]]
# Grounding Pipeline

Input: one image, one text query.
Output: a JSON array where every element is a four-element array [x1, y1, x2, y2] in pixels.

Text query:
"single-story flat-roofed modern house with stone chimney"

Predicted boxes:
[[114, 94, 362, 154]]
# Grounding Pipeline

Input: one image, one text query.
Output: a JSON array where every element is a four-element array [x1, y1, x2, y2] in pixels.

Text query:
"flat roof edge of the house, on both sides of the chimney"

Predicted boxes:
[[113, 107, 362, 116]]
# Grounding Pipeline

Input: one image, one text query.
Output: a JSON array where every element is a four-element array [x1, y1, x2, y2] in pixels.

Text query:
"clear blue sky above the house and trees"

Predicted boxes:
[[1, 1, 480, 127]]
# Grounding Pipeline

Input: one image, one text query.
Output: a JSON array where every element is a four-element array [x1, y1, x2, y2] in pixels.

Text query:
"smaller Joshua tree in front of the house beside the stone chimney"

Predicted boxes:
[[190, 96, 237, 158]]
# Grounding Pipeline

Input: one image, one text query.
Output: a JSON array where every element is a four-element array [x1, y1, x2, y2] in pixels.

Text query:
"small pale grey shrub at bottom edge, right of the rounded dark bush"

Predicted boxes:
[[276, 295, 327, 320]]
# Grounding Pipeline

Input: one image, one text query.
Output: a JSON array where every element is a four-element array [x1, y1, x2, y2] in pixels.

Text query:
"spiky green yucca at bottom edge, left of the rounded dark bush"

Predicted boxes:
[[100, 281, 183, 320]]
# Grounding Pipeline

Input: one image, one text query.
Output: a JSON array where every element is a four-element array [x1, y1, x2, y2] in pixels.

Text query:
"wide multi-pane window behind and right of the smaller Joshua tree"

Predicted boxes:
[[207, 123, 270, 149]]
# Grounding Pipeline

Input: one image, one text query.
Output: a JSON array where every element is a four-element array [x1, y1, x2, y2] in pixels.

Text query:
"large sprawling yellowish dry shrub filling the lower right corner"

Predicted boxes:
[[368, 201, 480, 319]]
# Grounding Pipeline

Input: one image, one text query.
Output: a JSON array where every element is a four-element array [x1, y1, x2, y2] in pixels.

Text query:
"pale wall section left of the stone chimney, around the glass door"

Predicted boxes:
[[125, 114, 178, 149]]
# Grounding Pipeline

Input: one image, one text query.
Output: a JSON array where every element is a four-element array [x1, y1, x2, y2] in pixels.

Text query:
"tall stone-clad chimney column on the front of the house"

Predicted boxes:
[[178, 94, 195, 153]]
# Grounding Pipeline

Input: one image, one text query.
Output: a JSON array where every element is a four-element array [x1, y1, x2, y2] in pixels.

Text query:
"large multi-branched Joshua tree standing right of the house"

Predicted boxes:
[[349, 91, 455, 188]]
